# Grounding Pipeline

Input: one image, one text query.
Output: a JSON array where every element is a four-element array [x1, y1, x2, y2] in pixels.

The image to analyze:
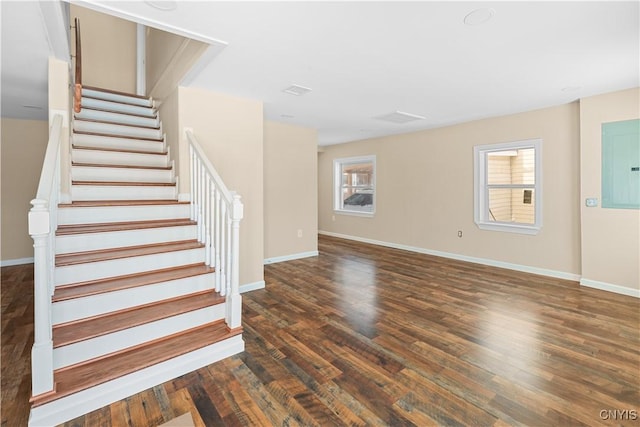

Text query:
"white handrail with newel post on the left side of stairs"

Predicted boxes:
[[29, 114, 63, 396]]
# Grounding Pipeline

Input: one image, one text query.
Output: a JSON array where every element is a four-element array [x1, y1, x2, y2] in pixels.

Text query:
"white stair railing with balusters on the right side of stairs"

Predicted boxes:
[[185, 129, 243, 329]]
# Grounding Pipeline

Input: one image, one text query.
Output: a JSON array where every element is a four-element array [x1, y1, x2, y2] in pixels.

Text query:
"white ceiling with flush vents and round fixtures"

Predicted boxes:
[[2, 1, 640, 145]]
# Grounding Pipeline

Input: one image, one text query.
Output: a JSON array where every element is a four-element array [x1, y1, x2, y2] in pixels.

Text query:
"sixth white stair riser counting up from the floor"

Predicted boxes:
[[58, 204, 191, 225]]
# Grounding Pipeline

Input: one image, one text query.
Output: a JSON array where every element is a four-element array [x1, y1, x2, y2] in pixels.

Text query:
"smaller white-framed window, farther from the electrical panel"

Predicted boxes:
[[333, 156, 376, 216]]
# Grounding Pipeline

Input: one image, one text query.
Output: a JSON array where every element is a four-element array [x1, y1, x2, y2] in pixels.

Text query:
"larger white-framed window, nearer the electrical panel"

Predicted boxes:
[[473, 139, 542, 234]]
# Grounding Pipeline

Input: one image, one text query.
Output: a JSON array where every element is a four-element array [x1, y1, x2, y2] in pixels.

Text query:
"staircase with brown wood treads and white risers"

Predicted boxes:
[[30, 87, 244, 426]]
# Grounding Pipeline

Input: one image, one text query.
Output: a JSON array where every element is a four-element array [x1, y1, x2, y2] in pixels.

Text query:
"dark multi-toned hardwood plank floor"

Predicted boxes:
[[2, 236, 640, 427]]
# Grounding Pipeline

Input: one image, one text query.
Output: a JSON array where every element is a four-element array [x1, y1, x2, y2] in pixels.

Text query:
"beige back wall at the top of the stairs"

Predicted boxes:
[[70, 4, 136, 93]]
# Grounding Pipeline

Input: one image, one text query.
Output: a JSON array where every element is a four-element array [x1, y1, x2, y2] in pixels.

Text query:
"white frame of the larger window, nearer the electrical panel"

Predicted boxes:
[[473, 139, 543, 234]]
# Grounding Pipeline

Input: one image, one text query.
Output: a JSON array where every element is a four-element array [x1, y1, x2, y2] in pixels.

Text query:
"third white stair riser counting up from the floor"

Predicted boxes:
[[51, 273, 215, 325]]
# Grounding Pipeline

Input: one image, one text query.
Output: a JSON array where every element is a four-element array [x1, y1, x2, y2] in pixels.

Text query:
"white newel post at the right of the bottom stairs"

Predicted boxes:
[[227, 193, 244, 329]]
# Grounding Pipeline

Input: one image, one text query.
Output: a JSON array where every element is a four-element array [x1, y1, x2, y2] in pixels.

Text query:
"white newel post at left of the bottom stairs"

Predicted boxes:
[[29, 199, 53, 396]]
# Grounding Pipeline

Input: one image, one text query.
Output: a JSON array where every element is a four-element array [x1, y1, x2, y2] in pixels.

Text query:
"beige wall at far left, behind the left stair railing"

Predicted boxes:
[[0, 119, 49, 262]]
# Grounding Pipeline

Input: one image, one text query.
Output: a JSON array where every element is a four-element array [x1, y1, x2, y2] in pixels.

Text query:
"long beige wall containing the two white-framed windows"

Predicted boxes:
[[318, 103, 580, 277]]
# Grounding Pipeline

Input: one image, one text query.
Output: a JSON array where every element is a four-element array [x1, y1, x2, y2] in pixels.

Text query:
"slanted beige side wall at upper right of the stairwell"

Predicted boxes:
[[145, 27, 208, 100]]
